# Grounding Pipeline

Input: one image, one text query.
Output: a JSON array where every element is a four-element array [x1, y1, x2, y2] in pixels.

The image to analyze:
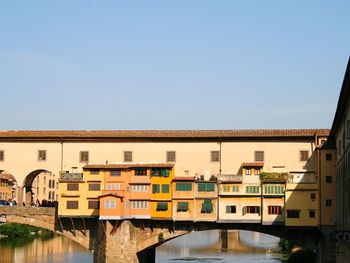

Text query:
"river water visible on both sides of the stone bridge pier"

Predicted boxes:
[[0, 230, 281, 263]]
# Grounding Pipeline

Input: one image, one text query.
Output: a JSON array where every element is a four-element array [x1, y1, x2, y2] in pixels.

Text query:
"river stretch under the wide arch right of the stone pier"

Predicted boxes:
[[156, 230, 282, 263]]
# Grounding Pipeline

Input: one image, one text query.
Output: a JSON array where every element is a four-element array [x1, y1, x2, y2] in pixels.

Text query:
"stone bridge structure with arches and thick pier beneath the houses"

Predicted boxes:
[[0, 207, 321, 263]]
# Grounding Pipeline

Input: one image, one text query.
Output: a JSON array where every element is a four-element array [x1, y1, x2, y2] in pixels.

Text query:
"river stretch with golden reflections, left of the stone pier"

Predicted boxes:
[[0, 236, 92, 263]]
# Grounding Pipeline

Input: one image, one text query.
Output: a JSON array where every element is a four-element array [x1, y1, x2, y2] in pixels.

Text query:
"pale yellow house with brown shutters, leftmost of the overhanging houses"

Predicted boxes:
[[58, 168, 104, 217]]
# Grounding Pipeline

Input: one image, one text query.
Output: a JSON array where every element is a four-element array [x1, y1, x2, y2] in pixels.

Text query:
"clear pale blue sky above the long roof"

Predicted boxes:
[[0, 0, 350, 130]]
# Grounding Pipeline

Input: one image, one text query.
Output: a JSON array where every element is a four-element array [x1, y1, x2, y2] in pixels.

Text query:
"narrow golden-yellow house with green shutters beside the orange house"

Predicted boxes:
[[151, 164, 174, 220]]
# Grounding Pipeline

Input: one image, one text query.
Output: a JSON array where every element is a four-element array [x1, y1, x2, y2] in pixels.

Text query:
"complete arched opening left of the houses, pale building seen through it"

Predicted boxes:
[[23, 169, 57, 206]]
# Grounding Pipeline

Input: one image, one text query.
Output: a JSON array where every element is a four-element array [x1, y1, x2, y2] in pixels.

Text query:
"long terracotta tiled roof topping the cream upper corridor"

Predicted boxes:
[[0, 129, 329, 140]]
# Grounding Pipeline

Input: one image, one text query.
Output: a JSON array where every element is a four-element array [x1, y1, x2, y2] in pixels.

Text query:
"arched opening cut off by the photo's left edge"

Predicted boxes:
[[0, 170, 17, 205]]
